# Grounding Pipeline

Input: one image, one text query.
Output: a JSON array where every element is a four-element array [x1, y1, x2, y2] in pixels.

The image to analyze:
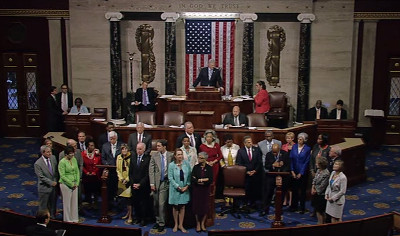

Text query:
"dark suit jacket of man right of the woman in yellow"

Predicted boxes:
[[129, 153, 151, 192]]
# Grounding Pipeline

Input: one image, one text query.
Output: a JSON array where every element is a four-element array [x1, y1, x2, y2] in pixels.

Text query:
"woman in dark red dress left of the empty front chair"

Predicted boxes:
[[200, 129, 223, 186]]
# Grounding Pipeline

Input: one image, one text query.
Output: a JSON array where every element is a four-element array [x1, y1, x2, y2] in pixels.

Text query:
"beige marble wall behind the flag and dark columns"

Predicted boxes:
[[70, 0, 355, 121]]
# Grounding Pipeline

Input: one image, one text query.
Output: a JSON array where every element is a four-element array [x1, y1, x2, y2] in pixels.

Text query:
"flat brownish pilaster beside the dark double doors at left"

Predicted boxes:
[[47, 17, 63, 87]]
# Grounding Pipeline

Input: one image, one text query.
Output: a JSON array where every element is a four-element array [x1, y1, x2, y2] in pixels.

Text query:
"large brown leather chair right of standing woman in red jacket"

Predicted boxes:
[[267, 91, 289, 125]]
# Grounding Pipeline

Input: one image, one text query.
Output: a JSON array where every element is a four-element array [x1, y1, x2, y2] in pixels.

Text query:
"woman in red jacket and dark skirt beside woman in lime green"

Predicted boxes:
[[82, 141, 101, 206]]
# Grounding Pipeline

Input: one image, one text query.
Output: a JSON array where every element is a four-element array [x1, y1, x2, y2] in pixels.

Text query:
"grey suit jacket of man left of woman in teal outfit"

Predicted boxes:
[[149, 152, 174, 189]]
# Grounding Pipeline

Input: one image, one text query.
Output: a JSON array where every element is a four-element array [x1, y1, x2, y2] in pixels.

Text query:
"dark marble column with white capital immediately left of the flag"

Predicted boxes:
[[161, 12, 179, 94]]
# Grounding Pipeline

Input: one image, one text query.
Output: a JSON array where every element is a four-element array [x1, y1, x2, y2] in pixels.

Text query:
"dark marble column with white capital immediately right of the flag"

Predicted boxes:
[[240, 13, 257, 95]]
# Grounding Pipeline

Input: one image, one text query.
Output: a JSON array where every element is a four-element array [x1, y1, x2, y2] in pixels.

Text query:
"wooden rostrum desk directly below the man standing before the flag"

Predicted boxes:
[[156, 98, 254, 129]]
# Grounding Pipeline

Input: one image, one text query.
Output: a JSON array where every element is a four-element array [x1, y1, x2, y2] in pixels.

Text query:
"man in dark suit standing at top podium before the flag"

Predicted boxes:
[[193, 59, 223, 89]]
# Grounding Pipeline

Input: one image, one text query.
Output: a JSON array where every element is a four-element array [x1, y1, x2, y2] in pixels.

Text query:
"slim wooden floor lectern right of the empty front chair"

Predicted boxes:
[[268, 172, 290, 228]]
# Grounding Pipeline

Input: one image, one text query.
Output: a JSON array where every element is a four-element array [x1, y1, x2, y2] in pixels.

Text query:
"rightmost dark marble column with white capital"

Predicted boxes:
[[296, 14, 315, 122]]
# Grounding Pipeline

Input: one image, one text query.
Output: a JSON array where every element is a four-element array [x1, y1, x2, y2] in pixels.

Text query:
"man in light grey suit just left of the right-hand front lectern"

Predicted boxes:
[[258, 130, 282, 215]]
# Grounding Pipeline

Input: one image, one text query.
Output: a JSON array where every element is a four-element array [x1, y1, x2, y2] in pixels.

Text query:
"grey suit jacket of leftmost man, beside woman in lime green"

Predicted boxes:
[[34, 155, 59, 193]]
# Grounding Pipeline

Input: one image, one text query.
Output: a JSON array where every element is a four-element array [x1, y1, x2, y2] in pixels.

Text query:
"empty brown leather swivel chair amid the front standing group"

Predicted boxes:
[[220, 165, 246, 219]]
